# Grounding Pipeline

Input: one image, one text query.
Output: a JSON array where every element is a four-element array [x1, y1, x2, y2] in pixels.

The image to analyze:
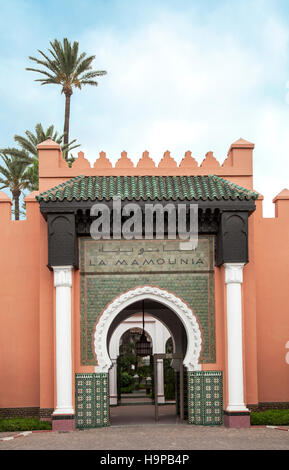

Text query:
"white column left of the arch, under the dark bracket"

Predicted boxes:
[[52, 266, 74, 415]]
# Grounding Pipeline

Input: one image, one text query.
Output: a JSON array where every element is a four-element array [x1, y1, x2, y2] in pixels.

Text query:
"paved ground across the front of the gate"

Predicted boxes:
[[0, 424, 289, 450]]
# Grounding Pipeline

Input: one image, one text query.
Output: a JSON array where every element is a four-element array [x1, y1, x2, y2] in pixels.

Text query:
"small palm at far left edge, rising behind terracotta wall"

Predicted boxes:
[[0, 152, 33, 220]]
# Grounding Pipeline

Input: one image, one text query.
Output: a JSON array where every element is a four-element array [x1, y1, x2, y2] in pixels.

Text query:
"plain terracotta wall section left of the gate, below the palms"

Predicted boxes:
[[0, 192, 40, 408]]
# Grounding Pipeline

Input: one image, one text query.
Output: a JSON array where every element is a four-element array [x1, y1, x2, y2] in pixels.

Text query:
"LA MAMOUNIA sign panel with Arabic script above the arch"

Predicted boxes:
[[82, 238, 212, 273]]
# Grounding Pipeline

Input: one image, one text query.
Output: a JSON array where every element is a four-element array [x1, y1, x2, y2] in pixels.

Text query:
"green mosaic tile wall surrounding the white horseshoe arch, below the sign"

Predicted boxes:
[[80, 236, 215, 365]]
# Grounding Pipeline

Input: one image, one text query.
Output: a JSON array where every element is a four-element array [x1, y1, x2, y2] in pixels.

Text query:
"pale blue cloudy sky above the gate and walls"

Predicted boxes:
[[0, 0, 289, 217]]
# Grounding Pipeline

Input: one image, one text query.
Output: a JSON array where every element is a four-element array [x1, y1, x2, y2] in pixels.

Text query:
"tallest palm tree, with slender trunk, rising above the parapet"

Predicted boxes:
[[26, 38, 107, 149]]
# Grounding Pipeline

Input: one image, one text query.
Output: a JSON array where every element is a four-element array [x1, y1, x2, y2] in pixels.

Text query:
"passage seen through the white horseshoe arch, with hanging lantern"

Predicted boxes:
[[108, 299, 187, 426]]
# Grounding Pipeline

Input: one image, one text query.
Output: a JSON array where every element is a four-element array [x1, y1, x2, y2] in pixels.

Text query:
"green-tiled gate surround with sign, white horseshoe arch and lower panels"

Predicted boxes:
[[76, 242, 223, 428]]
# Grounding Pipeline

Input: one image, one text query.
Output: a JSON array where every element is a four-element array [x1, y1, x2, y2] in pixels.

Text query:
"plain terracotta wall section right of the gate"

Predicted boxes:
[[254, 190, 289, 402]]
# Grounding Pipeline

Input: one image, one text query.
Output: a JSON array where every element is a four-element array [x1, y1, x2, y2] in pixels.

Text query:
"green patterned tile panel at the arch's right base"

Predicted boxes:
[[188, 371, 223, 426]]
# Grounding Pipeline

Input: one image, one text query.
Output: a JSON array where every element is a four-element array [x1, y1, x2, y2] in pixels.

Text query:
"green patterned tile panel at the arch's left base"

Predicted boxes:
[[75, 373, 109, 429]]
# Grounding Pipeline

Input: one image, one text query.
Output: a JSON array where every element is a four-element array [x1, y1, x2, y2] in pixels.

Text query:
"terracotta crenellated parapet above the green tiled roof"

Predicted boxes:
[[37, 139, 254, 192]]
